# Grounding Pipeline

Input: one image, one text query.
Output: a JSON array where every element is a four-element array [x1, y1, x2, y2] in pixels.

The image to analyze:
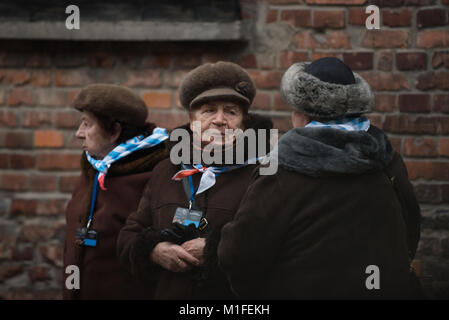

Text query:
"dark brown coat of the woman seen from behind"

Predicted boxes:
[[218, 127, 420, 299]]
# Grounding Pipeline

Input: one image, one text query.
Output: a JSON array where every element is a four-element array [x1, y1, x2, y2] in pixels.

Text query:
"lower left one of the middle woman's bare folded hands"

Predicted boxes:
[[150, 242, 200, 272]]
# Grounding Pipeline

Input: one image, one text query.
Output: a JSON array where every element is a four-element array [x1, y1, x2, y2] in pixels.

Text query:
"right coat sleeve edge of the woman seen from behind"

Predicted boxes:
[[388, 153, 421, 260]]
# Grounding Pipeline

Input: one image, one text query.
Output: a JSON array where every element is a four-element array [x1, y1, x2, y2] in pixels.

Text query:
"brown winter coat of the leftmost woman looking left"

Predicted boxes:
[[63, 144, 168, 299]]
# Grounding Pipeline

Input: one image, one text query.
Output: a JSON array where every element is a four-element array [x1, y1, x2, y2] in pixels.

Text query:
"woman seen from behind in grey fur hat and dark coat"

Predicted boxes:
[[218, 58, 420, 299]]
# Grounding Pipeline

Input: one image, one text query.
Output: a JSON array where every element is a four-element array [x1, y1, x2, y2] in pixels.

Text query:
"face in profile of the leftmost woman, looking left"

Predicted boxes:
[[75, 111, 118, 160]]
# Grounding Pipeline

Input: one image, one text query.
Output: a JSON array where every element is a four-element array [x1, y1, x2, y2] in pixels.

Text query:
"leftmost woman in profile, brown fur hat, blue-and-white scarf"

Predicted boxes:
[[63, 84, 168, 299]]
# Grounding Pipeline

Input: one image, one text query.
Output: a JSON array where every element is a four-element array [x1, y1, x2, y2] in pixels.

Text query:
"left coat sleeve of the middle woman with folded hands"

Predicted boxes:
[[117, 179, 162, 283]]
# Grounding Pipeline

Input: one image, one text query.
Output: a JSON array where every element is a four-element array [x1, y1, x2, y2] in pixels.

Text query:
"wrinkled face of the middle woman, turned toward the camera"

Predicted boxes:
[[190, 101, 244, 144]]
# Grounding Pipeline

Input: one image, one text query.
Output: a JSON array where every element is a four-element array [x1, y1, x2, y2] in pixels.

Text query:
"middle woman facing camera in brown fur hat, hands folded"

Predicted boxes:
[[118, 62, 272, 299]]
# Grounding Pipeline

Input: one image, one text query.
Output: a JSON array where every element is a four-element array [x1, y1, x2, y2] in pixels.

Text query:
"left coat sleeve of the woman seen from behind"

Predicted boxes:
[[218, 171, 289, 298]]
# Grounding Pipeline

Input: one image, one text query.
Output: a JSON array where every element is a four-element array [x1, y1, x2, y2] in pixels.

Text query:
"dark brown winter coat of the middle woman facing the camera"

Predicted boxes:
[[118, 116, 272, 299]]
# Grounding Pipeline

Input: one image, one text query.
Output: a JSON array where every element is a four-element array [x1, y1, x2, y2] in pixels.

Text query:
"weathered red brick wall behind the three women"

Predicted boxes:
[[0, 0, 449, 299]]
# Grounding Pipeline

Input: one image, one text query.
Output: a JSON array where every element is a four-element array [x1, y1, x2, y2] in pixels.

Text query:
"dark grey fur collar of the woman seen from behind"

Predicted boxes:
[[278, 126, 394, 177]]
